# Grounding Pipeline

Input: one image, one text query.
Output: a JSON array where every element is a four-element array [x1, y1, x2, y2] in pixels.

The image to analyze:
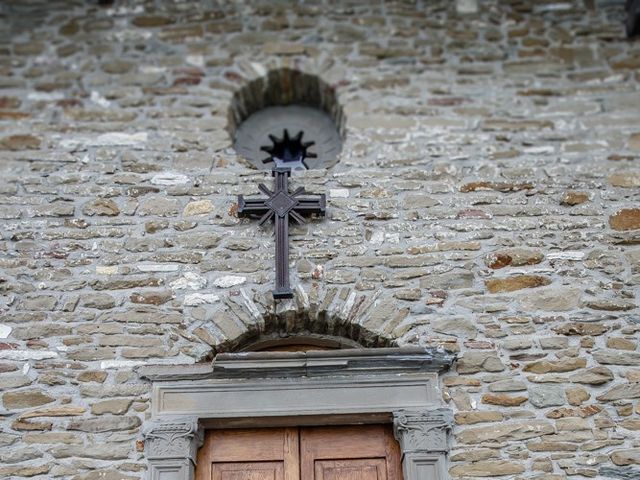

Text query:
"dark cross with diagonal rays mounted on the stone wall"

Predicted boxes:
[[238, 167, 326, 298]]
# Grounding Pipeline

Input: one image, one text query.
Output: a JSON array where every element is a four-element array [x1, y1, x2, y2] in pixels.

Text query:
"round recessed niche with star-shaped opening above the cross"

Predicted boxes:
[[230, 69, 342, 170]]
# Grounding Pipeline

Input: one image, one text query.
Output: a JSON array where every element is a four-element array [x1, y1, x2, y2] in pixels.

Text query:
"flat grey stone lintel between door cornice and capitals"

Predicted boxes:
[[152, 372, 441, 420]]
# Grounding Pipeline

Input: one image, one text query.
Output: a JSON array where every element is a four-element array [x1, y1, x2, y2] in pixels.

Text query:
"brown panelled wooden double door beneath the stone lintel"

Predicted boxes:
[[196, 425, 402, 480]]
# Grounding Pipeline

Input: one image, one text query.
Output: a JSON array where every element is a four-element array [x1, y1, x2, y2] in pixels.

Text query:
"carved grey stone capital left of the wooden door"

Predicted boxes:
[[143, 417, 204, 464]]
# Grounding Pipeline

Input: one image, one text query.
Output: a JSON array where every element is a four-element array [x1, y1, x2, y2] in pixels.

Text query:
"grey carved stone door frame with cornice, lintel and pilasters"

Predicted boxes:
[[139, 348, 454, 480]]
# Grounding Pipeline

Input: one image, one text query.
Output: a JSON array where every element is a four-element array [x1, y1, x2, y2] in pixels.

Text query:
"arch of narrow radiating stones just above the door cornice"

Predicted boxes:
[[193, 284, 397, 355]]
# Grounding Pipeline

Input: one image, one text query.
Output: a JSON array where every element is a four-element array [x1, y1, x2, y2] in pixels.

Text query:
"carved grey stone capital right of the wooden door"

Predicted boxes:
[[393, 408, 453, 455]]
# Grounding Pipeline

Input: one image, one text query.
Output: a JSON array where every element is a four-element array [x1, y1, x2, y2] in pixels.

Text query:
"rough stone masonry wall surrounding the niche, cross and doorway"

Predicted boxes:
[[0, 0, 640, 480]]
